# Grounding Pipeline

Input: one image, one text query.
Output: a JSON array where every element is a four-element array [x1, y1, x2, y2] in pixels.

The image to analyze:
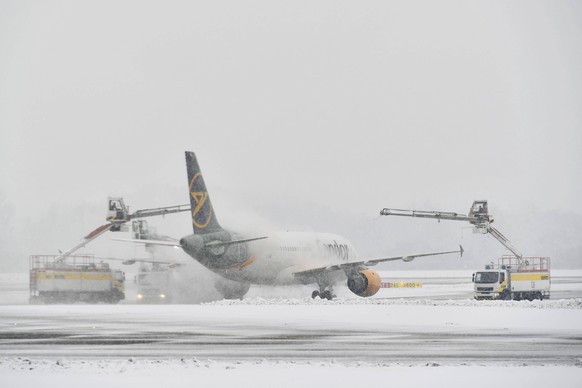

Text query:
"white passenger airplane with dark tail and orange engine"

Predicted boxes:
[[125, 151, 463, 300]]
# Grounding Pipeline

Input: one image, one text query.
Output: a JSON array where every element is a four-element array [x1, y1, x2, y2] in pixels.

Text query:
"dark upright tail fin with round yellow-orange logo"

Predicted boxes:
[[186, 151, 222, 234]]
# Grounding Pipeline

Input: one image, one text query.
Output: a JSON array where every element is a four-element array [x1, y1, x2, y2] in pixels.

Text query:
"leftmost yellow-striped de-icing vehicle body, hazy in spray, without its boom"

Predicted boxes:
[[30, 255, 125, 303]]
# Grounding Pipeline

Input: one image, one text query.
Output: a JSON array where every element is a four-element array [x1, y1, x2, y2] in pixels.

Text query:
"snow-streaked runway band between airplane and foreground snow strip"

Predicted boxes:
[[0, 298, 582, 365]]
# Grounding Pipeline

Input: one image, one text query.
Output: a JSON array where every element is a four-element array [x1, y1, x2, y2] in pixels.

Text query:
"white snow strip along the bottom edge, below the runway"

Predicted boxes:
[[0, 358, 582, 388]]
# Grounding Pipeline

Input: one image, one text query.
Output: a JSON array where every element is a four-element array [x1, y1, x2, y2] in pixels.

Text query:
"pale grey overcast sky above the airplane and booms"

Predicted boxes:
[[0, 0, 582, 269]]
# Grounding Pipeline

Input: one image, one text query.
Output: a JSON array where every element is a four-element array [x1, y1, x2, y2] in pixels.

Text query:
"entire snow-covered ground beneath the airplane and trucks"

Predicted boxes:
[[0, 272, 582, 387]]
